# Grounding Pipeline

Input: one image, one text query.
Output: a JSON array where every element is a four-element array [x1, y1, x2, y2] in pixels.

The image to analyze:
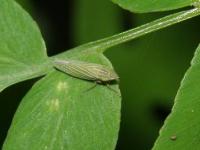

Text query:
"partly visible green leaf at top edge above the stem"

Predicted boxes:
[[112, 0, 198, 13]]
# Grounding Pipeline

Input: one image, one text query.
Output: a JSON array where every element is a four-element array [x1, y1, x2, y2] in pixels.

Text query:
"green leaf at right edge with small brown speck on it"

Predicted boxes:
[[153, 45, 200, 150]]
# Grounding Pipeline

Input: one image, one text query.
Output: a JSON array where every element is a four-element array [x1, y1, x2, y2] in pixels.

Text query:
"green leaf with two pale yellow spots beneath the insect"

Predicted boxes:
[[3, 51, 121, 150]]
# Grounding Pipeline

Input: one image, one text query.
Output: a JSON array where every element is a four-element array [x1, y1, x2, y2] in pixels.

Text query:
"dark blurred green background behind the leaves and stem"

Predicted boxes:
[[0, 0, 200, 150]]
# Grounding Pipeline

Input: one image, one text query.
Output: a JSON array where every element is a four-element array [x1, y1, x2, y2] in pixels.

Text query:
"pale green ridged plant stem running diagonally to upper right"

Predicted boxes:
[[85, 8, 200, 51]]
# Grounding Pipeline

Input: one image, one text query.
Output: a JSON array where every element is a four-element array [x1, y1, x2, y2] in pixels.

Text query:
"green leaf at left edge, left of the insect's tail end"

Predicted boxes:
[[0, 0, 50, 91]]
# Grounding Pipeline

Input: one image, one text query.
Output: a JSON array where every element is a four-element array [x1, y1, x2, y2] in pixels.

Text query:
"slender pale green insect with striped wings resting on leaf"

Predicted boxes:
[[54, 60, 119, 93]]
